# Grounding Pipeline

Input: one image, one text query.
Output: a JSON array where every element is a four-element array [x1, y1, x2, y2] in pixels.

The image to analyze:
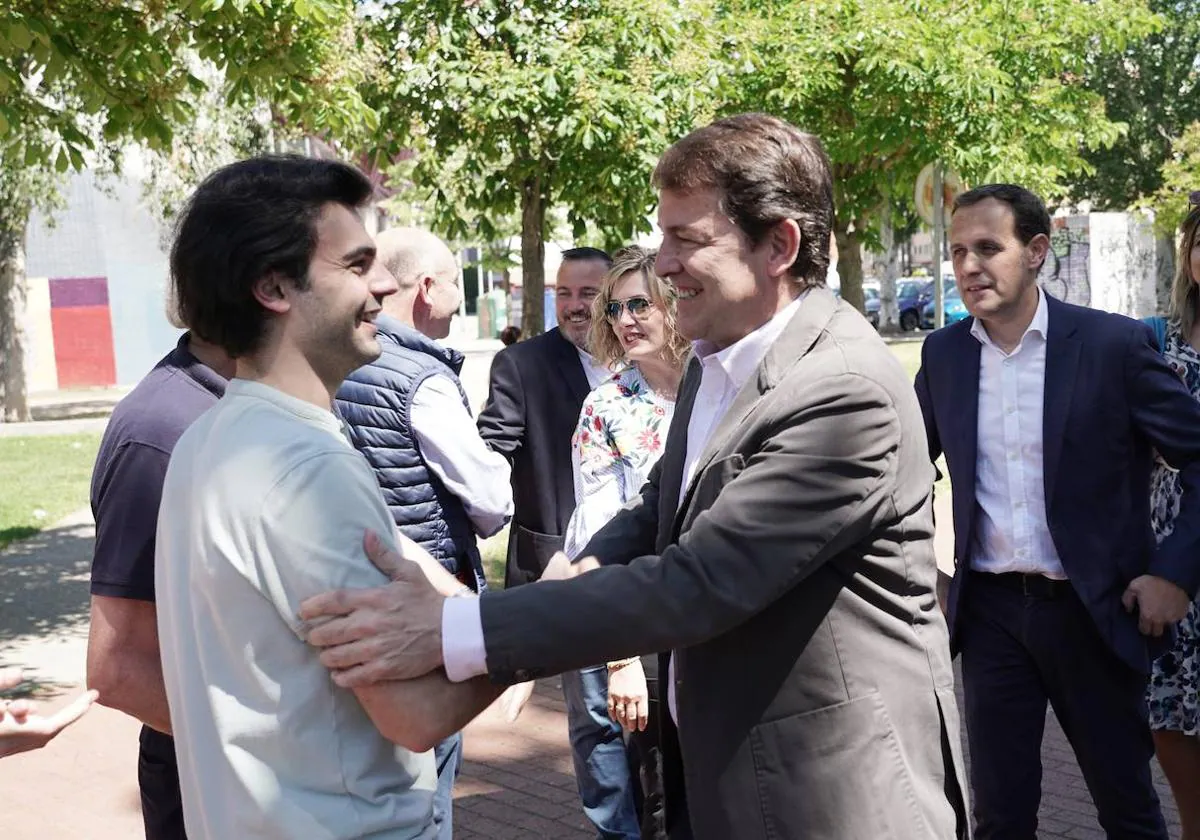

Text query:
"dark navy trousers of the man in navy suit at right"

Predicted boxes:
[[959, 572, 1168, 840]]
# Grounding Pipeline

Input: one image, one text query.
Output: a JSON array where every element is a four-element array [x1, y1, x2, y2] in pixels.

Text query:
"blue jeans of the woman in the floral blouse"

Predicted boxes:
[[563, 665, 641, 840]]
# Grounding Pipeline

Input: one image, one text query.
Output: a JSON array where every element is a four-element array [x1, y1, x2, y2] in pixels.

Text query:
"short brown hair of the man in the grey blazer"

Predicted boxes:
[[653, 114, 833, 288]]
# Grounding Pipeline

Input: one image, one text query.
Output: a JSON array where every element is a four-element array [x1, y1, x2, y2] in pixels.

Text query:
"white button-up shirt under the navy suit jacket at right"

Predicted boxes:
[[970, 289, 1067, 580]]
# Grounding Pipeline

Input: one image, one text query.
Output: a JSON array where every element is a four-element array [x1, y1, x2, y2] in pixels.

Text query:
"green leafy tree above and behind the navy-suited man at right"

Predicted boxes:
[[722, 0, 1153, 307]]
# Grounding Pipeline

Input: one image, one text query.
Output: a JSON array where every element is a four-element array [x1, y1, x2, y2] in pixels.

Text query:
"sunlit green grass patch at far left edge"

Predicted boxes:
[[0, 434, 100, 548]]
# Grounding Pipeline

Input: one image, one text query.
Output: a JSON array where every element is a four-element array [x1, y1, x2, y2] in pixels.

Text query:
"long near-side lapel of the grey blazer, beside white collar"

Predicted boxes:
[[676, 288, 839, 528]]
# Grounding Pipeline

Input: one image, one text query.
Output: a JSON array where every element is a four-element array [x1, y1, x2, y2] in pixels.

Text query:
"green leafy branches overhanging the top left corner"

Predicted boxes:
[[0, 0, 374, 419]]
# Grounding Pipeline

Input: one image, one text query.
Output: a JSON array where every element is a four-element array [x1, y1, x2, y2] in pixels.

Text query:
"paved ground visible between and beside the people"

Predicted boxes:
[[0, 506, 1178, 840]]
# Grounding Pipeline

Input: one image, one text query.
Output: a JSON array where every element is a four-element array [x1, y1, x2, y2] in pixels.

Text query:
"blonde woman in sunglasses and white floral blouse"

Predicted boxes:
[[564, 246, 689, 840]]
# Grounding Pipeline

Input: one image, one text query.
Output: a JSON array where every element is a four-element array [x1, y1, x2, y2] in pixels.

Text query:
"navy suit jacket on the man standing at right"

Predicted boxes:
[[917, 295, 1200, 672]]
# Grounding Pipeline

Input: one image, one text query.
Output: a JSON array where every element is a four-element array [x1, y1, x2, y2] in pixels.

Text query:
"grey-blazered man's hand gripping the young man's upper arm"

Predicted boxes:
[[300, 532, 445, 688]]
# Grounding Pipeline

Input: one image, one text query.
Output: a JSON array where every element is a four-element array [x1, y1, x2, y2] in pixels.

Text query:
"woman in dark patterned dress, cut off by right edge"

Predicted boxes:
[[1146, 191, 1200, 840]]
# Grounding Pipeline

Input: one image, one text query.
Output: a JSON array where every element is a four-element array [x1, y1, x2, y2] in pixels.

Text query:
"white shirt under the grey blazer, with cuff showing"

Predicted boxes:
[[442, 295, 804, 691]]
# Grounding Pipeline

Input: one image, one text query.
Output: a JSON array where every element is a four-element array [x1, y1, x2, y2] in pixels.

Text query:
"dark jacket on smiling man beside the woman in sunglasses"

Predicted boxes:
[[479, 328, 589, 587]]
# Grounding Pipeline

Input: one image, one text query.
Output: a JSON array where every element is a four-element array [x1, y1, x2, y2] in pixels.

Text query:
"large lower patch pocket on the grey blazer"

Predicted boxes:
[[750, 694, 931, 840]]
